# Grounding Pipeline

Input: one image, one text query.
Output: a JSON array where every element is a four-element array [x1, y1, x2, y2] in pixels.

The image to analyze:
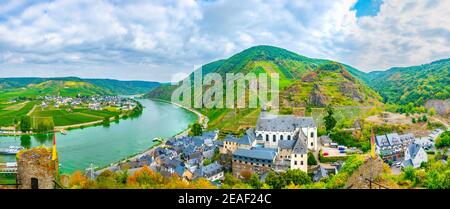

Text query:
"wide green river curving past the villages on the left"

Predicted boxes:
[[0, 99, 197, 173]]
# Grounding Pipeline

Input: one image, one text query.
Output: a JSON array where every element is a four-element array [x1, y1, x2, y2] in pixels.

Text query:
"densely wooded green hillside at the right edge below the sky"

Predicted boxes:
[[368, 59, 450, 105]]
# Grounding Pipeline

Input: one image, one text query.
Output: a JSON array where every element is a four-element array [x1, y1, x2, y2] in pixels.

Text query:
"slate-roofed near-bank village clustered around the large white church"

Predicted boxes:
[[86, 111, 444, 186]]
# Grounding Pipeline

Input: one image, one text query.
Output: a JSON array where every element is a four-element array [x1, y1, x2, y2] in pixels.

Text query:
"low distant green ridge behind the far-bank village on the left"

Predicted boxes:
[[0, 77, 159, 98]]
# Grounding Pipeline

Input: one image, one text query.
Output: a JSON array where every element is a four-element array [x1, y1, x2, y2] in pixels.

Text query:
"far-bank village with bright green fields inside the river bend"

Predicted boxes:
[[0, 94, 142, 135]]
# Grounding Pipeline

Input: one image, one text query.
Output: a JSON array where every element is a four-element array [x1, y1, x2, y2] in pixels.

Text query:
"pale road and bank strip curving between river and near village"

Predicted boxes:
[[96, 99, 209, 174]]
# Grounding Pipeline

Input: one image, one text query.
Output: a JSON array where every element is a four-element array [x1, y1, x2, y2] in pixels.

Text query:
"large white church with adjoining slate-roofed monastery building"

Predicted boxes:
[[225, 111, 318, 176]]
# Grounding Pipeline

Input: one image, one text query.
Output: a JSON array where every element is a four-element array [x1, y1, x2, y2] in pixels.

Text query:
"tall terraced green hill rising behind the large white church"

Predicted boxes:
[[148, 46, 381, 131]]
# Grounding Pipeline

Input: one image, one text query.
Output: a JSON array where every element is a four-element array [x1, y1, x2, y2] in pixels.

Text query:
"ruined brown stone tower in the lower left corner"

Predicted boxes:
[[17, 147, 58, 189]]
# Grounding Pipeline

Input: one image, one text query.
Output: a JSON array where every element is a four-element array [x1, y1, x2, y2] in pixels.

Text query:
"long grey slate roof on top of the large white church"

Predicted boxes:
[[256, 111, 316, 132]]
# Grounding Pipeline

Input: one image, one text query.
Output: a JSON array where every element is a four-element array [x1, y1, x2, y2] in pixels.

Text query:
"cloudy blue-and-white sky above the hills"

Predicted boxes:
[[0, 0, 450, 81]]
